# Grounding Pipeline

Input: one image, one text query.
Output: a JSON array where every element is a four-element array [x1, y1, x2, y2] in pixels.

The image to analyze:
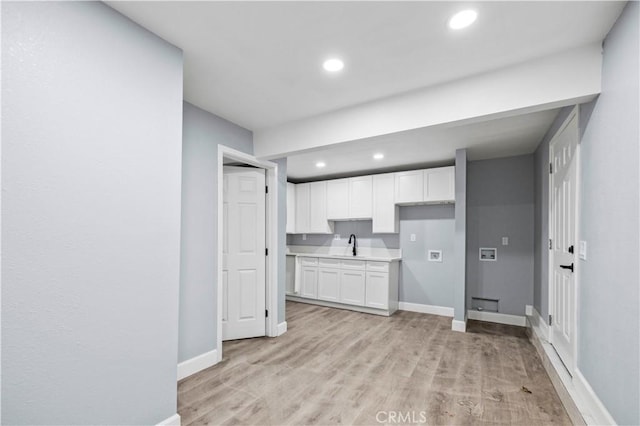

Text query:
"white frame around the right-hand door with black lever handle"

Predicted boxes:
[[546, 105, 582, 377]]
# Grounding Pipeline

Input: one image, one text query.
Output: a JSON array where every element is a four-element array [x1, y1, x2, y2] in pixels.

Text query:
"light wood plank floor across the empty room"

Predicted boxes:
[[178, 302, 571, 425]]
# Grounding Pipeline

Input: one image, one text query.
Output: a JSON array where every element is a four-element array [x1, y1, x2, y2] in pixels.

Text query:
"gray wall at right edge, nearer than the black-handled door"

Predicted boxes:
[[578, 2, 640, 424]]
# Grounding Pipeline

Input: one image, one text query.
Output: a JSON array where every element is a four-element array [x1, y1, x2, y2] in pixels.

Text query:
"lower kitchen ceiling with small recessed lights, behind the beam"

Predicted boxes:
[[287, 109, 558, 182]]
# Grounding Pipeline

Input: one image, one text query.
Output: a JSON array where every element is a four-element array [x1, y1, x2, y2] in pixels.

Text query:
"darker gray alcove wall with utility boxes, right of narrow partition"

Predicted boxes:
[[467, 154, 534, 315]]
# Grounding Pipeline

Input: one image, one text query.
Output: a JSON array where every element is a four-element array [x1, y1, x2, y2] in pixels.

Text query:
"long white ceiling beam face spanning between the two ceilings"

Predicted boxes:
[[254, 43, 602, 158]]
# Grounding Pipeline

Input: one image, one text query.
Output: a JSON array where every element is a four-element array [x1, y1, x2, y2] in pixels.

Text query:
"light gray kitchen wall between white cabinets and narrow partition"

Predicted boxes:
[[399, 205, 456, 307]]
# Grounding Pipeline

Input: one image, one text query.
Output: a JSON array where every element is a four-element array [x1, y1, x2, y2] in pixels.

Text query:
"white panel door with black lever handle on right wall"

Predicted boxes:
[[550, 115, 578, 374]]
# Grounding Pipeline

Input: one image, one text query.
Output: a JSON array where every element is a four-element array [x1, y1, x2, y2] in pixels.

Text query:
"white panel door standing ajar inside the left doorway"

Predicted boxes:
[[222, 166, 266, 340]]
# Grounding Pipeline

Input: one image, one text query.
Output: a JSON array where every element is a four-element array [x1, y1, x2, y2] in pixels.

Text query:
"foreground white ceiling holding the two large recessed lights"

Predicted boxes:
[[108, 1, 624, 130]]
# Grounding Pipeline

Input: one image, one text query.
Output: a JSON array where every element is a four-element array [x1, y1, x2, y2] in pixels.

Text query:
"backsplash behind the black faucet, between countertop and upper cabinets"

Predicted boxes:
[[287, 220, 400, 249]]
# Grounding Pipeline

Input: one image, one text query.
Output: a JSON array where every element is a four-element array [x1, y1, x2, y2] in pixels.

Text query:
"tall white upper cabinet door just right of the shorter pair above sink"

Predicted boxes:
[[372, 173, 399, 234]]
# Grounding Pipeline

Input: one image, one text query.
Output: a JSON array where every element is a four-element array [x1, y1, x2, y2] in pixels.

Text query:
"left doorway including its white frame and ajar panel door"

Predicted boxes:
[[216, 145, 278, 361]]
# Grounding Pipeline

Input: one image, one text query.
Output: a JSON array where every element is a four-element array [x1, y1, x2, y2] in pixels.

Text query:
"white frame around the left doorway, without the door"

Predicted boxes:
[[216, 145, 279, 362]]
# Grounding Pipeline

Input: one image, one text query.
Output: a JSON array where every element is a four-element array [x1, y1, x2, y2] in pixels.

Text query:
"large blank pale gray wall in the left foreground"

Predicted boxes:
[[2, 2, 182, 425]]
